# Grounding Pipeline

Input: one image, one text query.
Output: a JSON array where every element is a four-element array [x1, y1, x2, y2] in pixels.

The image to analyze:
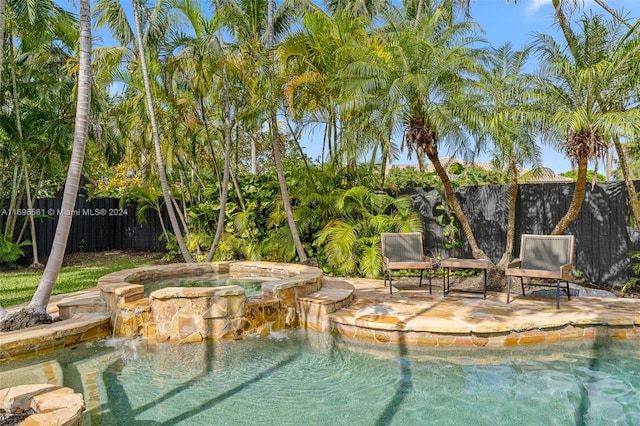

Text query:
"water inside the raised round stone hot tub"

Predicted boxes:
[[144, 274, 273, 297]]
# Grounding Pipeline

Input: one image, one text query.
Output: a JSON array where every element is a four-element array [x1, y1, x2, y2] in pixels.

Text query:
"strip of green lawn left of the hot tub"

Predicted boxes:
[[0, 254, 164, 308]]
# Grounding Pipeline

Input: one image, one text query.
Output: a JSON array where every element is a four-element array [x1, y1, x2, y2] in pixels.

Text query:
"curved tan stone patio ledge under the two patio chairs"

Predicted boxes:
[[326, 278, 640, 346]]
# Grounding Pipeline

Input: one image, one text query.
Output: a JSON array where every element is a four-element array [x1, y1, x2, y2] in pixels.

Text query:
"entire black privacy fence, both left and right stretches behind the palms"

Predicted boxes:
[[0, 181, 640, 284]]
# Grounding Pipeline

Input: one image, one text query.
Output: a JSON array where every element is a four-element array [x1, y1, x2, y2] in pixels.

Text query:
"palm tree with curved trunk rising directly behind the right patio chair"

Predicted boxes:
[[536, 11, 640, 234]]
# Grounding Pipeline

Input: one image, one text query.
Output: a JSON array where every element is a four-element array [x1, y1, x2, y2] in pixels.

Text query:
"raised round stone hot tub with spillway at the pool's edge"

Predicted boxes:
[[98, 262, 322, 342]]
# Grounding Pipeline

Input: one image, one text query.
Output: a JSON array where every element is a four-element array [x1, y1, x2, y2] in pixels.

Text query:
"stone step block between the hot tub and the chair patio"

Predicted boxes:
[[298, 277, 354, 330]]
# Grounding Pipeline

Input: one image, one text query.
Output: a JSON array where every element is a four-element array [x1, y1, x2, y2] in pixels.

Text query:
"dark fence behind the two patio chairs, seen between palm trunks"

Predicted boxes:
[[405, 181, 640, 284]]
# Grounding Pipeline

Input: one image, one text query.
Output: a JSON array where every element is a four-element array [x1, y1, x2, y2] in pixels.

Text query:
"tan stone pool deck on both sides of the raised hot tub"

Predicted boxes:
[[0, 277, 640, 362]]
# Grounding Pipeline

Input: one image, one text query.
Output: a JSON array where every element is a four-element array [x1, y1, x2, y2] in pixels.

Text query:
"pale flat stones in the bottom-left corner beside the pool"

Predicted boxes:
[[0, 384, 85, 426]]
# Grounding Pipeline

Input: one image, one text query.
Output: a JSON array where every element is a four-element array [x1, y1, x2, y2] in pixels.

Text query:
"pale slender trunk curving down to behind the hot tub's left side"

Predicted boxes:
[[133, 0, 193, 263]]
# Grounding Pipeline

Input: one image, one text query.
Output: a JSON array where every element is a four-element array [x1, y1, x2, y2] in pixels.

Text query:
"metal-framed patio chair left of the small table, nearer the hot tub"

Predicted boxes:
[[381, 232, 433, 294]]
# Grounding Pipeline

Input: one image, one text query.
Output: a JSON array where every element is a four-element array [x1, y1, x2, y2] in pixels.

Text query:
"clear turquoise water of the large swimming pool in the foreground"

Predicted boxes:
[[0, 329, 640, 425]]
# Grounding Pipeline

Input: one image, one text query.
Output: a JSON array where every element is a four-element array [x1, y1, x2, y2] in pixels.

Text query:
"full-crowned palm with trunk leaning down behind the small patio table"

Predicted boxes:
[[347, 8, 489, 259]]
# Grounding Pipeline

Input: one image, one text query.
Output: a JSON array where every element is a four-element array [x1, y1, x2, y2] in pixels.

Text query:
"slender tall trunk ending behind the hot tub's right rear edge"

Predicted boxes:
[[267, 0, 307, 262]]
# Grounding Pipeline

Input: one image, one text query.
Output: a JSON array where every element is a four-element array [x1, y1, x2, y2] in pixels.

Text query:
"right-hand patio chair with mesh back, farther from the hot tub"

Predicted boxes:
[[505, 234, 574, 309]]
